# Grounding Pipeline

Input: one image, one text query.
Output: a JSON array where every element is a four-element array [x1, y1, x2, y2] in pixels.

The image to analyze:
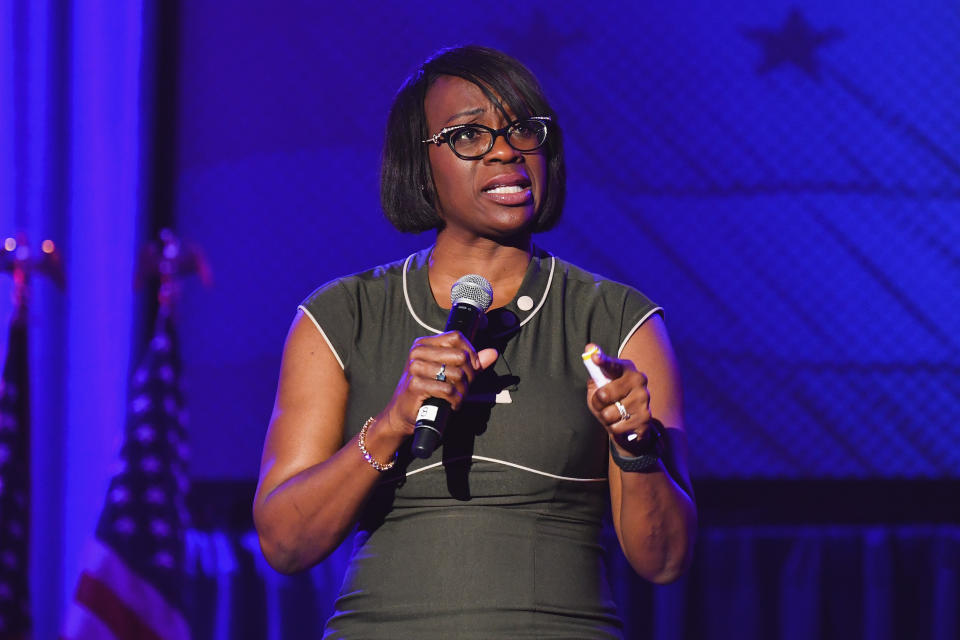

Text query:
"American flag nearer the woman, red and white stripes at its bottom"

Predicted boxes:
[[63, 305, 190, 640]]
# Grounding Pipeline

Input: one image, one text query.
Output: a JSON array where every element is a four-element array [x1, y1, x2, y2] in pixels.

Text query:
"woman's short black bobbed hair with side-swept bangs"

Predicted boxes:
[[380, 45, 567, 233]]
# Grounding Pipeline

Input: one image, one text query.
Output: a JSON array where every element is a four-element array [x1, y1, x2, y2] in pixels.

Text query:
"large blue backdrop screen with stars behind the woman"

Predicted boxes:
[[176, 0, 960, 479]]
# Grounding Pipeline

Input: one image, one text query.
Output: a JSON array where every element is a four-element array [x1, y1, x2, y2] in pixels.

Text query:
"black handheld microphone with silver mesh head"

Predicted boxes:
[[411, 274, 493, 458]]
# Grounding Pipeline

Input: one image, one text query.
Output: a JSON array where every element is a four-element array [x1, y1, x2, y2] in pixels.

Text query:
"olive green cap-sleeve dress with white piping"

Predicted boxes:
[[301, 249, 661, 639]]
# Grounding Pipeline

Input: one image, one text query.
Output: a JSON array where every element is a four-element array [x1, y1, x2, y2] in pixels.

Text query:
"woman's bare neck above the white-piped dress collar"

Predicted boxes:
[[428, 232, 533, 309]]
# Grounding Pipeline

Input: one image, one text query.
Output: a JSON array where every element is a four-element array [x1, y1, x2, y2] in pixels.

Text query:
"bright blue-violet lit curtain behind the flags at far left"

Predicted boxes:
[[0, 0, 157, 639]]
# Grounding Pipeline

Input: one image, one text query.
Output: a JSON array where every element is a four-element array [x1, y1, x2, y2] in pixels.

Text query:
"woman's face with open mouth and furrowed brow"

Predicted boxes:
[[424, 76, 547, 244]]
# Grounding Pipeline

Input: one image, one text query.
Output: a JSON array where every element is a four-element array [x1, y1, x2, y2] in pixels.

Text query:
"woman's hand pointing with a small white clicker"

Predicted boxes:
[[585, 343, 653, 445]]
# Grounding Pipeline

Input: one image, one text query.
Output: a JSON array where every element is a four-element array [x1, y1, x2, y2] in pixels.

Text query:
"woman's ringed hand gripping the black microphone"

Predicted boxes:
[[371, 331, 499, 450]]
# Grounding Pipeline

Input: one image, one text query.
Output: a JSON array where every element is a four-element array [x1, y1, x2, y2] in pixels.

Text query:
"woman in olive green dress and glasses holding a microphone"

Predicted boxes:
[[254, 47, 696, 638]]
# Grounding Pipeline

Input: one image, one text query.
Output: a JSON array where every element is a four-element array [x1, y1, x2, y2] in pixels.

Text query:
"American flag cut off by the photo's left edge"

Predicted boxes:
[[0, 304, 30, 639]]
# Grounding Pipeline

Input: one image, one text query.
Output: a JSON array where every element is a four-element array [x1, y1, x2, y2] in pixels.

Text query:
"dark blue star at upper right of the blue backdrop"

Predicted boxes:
[[741, 8, 844, 79]]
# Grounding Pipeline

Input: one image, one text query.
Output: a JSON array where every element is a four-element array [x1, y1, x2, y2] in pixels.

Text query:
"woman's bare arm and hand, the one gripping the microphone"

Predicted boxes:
[[253, 312, 497, 573]]
